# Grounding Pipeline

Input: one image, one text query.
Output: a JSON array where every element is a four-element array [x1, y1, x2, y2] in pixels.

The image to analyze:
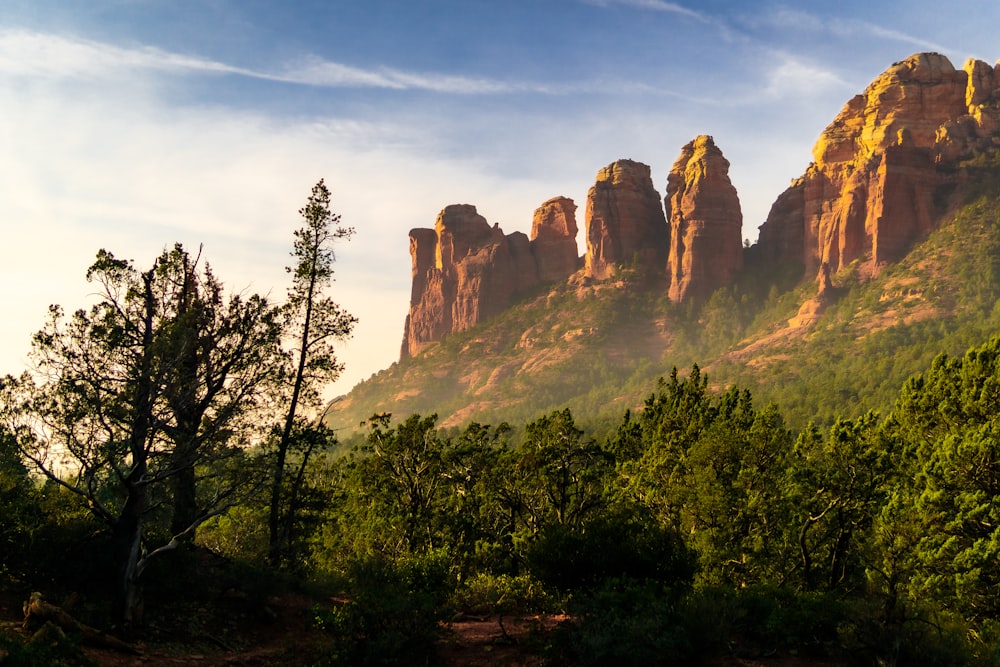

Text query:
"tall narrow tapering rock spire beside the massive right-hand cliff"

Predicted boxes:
[[664, 135, 743, 302]]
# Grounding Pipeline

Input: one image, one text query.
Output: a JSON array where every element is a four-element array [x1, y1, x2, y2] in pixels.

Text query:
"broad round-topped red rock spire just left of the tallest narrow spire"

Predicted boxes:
[[584, 160, 668, 280]]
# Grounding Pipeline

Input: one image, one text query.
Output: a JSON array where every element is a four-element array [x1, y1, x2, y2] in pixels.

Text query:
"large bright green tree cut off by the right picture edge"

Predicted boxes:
[[893, 336, 1000, 623]]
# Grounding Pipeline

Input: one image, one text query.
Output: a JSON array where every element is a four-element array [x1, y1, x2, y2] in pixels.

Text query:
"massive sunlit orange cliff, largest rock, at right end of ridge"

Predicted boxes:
[[758, 53, 1000, 275]]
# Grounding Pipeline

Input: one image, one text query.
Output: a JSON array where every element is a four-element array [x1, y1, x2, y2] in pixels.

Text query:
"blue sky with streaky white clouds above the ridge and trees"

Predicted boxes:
[[0, 0, 1000, 395]]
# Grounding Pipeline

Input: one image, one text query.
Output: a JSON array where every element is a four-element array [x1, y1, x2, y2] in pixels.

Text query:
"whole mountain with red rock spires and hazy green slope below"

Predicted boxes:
[[328, 54, 1000, 430]]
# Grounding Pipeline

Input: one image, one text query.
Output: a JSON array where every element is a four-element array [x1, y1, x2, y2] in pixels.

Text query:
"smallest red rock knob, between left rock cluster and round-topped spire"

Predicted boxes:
[[531, 197, 580, 282]]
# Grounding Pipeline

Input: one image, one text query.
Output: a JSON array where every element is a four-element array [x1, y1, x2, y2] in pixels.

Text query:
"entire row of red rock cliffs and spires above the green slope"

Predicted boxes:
[[401, 53, 1000, 358]]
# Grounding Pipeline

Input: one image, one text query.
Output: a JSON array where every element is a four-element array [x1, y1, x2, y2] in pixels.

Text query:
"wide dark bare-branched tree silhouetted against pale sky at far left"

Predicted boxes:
[[4, 245, 280, 631]]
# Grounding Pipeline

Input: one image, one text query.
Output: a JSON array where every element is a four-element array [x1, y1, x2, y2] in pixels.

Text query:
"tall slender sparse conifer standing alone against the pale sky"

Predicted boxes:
[[268, 179, 357, 565]]
